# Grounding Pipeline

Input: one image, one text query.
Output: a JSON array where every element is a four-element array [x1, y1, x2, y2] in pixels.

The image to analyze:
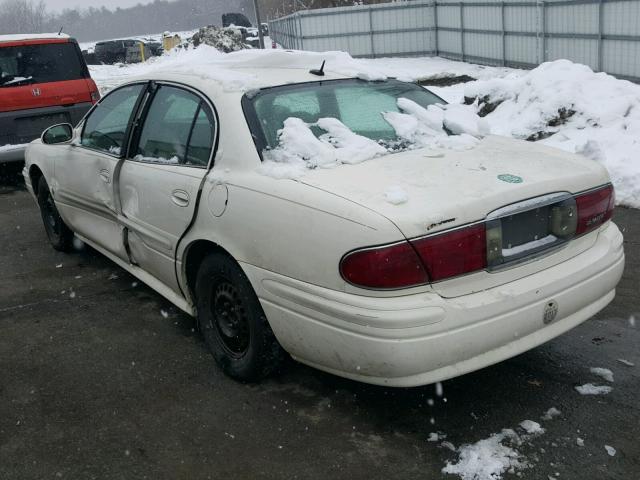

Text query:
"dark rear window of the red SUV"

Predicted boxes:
[[0, 43, 86, 88]]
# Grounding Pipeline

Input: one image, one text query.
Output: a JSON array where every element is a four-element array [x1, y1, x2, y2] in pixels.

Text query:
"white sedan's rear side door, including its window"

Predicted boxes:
[[118, 83, 217, 293]]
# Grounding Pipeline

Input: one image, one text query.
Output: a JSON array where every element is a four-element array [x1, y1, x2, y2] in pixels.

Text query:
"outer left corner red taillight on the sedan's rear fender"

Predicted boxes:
[[340, 242, 429, 288]]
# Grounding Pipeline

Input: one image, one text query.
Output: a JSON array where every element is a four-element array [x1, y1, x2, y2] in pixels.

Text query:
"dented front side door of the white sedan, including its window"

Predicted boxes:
[[52, 83, 146, 260]]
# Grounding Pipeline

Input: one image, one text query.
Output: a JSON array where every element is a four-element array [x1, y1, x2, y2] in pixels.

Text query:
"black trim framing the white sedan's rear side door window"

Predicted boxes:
[[125, 80, 220, 171]]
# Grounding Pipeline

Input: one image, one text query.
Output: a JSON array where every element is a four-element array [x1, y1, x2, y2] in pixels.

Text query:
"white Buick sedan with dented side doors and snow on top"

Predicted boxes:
[[24, 62, 624, 386]]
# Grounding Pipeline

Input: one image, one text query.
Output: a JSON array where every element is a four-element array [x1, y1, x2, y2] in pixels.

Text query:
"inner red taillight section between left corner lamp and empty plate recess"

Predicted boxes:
[[411, 223, 487, 282]]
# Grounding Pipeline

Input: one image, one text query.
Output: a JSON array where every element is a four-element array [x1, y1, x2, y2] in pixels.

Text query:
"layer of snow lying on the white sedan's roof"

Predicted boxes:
[[124, 45, 387, 92]]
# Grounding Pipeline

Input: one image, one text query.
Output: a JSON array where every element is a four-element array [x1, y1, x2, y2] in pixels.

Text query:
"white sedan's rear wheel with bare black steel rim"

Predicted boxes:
[[195, 253, 285, 381]]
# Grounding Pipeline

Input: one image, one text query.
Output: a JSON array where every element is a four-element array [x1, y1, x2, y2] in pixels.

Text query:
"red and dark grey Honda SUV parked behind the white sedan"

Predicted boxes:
[[0, 34, 100, 164]]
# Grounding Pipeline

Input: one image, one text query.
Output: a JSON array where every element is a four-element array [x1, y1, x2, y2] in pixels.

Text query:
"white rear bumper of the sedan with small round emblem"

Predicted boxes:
[[243, 223, 624, 387]]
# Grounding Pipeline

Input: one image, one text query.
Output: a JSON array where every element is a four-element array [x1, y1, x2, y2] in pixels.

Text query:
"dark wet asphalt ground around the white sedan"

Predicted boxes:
[[0, 166, 640, 480]]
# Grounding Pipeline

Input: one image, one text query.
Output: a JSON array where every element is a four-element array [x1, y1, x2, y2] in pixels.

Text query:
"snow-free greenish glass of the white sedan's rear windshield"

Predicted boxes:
[[245, 79, 446, 150]]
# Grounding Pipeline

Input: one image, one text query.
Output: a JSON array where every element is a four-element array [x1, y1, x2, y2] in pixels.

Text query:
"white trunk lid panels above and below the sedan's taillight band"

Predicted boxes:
[[301, 136, 609, 296]]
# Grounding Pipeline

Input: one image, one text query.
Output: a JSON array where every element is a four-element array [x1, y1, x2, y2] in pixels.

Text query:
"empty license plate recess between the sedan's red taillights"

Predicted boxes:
[[486, 193, 577, 271]]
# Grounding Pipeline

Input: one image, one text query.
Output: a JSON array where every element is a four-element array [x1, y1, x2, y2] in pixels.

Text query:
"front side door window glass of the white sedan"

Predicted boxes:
[[81, 84, 145, 156]]
